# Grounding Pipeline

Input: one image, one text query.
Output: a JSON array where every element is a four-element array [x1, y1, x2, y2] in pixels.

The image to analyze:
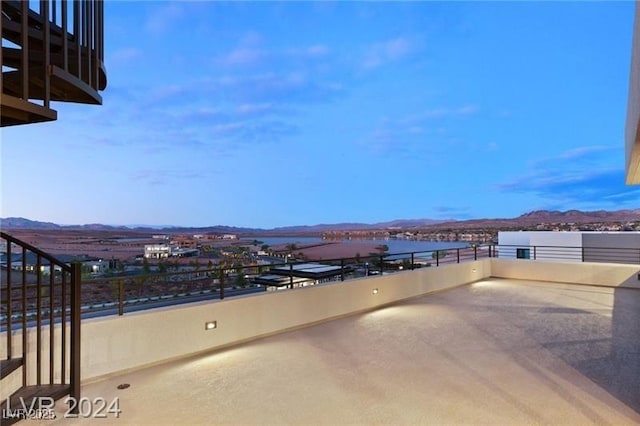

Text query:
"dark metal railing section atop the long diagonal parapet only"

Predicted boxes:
[[47, 246, 482, 321]]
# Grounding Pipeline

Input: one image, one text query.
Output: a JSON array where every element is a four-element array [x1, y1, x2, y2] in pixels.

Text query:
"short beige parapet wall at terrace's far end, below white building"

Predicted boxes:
[[491, 258, 640, 288]]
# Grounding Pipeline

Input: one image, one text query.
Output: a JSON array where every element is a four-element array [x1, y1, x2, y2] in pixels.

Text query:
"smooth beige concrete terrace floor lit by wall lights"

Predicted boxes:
[[33, 279, 640, 425]]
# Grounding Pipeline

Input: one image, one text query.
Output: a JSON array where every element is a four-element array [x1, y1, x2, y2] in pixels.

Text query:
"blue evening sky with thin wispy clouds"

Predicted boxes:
[[1, 1, 640, 228]]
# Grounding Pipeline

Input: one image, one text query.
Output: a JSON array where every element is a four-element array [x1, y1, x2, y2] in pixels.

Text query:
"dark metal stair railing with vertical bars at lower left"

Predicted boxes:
[[0, 232, 81, 406]]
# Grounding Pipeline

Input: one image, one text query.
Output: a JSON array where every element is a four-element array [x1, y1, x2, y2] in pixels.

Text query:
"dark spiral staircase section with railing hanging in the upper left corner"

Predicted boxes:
[[0, 0, 107, 126]]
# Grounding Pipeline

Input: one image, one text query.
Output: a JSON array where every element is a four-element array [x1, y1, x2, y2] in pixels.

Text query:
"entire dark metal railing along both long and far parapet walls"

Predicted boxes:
[[0, 245, 640, 326]]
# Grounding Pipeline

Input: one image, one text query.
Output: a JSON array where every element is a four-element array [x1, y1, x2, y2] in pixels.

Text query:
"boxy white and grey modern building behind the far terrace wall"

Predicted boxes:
[[498, 231, 640, 263]]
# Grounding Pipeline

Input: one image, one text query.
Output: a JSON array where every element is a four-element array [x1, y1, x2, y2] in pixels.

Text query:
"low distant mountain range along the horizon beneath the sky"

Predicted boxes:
[[0, 209, 640, 234]]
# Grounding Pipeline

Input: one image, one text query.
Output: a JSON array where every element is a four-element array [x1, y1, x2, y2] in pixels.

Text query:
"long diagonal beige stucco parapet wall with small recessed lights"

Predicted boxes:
[[82, 259, 490, 381]]
